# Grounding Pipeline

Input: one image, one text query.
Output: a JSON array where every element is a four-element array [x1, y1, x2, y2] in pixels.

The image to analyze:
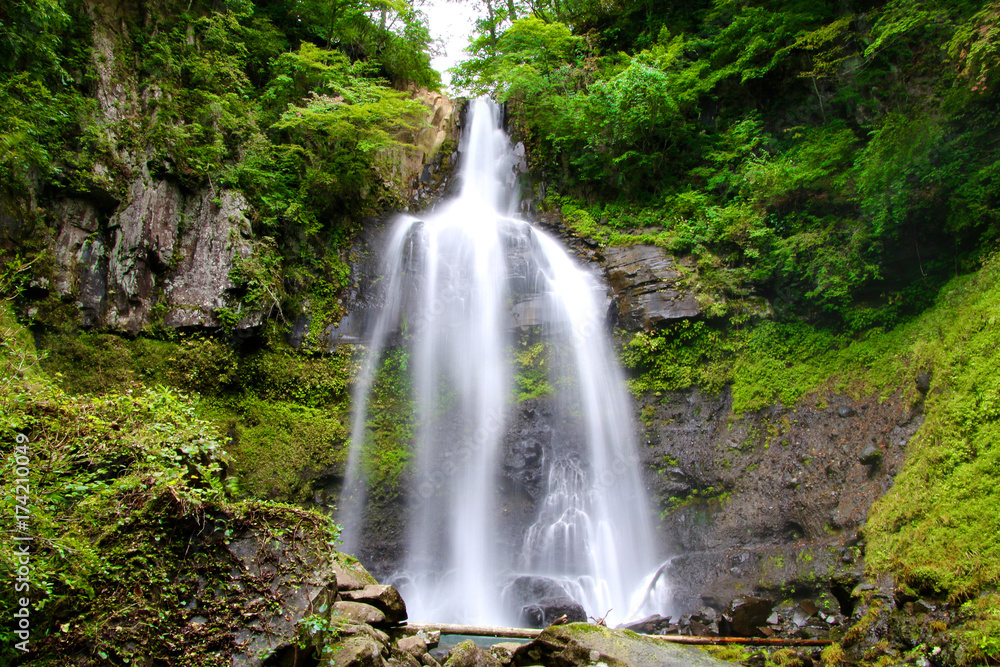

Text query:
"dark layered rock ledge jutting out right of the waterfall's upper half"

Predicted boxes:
[[604, 245, 701, 331]]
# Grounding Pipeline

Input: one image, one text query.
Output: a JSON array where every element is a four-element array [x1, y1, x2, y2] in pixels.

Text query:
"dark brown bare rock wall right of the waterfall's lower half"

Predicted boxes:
[[637, 391, 923, 622]]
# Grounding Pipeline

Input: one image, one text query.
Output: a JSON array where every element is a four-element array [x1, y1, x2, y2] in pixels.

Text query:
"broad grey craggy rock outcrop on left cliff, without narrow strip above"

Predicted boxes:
[[55, 184, 259, 333]]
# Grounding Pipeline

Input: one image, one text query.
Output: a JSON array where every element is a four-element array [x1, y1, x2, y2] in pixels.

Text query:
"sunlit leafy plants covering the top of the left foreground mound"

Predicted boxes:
[[0, 353, 226, 649]]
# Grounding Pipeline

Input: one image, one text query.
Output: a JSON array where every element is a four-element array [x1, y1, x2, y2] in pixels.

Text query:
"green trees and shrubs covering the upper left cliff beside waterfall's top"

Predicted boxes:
[[0, 0, 439, 345]]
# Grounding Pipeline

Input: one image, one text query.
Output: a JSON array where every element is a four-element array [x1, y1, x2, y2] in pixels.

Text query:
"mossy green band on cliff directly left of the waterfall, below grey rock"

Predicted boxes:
[[43, 334, 368, 502]]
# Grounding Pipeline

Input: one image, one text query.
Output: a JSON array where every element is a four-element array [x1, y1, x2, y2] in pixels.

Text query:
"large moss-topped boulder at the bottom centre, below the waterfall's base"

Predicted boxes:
[[514, 623, 734, 667]]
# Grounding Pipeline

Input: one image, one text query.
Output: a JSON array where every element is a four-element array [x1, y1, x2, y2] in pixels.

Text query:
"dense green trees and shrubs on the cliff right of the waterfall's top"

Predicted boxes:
[[457, 0, 1000, 331]]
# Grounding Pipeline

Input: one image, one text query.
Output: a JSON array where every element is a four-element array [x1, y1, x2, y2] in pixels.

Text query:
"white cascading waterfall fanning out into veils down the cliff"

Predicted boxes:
[[340, 100, 664, 624]]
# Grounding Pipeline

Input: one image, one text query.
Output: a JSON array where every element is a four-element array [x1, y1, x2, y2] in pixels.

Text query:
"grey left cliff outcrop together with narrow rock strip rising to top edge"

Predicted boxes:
[[42, 0, 259, 334]]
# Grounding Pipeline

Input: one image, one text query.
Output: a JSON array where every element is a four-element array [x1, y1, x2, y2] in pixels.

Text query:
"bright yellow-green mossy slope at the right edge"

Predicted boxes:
[[865, 253, 1000, 599]]
